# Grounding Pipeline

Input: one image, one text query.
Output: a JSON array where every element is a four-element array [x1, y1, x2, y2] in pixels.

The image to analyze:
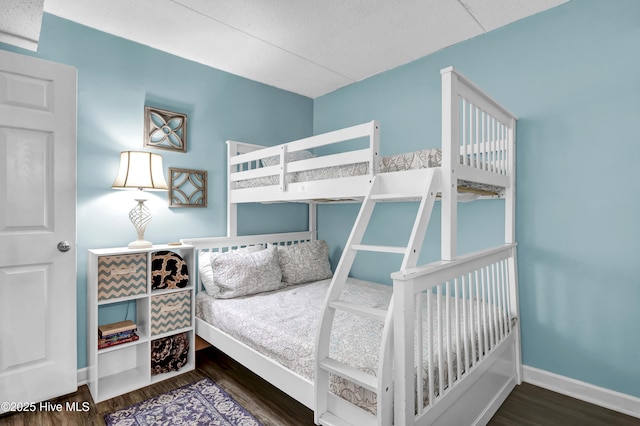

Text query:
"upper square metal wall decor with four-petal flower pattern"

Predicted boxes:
[[144, 106, 187, 152]]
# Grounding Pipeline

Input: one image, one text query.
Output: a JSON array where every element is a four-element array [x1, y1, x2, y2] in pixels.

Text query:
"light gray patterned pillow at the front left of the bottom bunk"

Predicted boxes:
[[211, 247, 284, 299]]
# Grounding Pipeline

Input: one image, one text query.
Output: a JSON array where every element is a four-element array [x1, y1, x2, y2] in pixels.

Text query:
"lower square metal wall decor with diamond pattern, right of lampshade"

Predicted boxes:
[[169, 167, 207, 207]]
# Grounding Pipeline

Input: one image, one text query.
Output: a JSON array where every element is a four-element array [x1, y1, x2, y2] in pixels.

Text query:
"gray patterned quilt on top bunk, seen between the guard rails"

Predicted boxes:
[[234, 148, 502, 193]]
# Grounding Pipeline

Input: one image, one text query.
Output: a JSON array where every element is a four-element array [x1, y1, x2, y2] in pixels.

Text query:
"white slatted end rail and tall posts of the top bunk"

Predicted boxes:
[[440, 67, 517, 260]]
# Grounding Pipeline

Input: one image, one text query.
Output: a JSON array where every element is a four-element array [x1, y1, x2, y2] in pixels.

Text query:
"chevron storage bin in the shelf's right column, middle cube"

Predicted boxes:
[[151, 290, 191, 336]]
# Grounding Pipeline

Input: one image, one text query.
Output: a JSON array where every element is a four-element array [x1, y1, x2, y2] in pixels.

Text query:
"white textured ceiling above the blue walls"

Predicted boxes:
[[44, 0, 567, 98]]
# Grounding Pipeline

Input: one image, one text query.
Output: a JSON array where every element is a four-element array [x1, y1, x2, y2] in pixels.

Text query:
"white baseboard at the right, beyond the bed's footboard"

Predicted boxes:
[[522, 365, 640, 418]]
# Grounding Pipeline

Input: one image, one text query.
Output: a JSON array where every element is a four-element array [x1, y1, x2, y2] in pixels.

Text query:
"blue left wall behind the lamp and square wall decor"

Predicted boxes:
[[0, 14, 313, 368]]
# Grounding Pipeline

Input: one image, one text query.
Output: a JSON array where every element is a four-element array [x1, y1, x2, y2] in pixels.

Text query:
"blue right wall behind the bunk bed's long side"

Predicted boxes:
[[314, 0, 640, 397]]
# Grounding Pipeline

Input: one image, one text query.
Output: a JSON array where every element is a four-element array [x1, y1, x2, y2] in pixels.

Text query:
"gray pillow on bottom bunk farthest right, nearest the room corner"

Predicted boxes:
[[278, 240, 333, 285]]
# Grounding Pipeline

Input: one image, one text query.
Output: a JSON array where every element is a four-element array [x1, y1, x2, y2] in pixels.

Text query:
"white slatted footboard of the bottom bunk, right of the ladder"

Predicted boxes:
[[392, 244, 520, 425]]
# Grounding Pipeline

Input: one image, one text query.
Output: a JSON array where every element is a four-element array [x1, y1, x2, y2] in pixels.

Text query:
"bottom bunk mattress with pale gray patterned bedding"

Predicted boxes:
[[196, 278, 504, 414]]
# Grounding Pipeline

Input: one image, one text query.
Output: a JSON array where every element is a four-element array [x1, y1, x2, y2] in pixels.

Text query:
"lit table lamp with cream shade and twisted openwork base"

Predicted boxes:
[[111, 151, 169, 249]]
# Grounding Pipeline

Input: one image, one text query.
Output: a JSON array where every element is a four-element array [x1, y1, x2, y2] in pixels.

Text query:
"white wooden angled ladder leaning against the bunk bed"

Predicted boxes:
[[315, 169, 440, 426]]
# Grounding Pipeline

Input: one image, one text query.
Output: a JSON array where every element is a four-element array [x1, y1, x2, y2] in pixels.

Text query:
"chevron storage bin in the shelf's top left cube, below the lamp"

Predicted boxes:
[[98, 253, 147, 300]]
